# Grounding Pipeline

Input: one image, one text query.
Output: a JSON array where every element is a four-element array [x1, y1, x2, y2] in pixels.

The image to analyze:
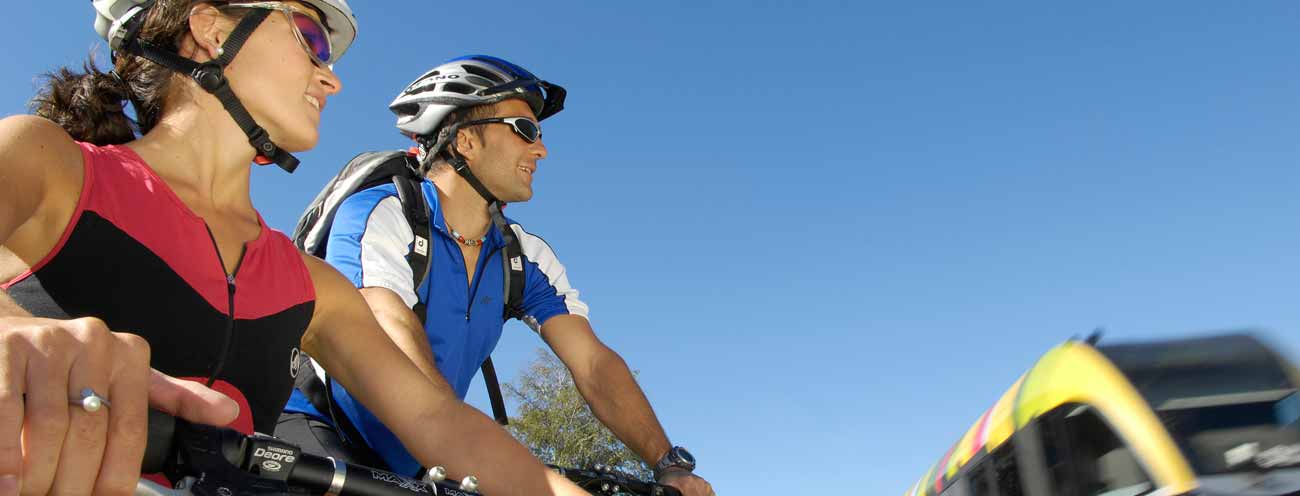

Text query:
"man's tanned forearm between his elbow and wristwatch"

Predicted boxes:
[[573, 348, 671, 466]]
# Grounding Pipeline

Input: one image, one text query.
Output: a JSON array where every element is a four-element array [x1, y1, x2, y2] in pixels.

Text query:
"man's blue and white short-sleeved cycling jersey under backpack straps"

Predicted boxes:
[[285, 180, 588, 477]]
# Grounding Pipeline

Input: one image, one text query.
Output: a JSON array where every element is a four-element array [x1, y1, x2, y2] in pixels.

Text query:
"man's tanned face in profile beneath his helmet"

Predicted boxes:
[[467, 99, 546, 203]]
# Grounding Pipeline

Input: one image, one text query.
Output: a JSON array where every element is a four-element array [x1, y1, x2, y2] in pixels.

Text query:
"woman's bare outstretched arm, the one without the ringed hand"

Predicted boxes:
[[303, 254, 586, 496]]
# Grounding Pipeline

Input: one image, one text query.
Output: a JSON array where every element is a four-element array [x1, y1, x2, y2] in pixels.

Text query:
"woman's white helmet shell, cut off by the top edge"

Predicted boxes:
[[91, 0, 356, 64]]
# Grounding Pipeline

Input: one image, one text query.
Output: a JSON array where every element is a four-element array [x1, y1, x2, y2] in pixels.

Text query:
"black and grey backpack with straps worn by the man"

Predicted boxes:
[[291, 151, 524, 460]]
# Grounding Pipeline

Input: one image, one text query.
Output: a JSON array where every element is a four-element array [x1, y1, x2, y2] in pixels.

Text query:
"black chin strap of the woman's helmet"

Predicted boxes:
[[121, 9, 298, 173]]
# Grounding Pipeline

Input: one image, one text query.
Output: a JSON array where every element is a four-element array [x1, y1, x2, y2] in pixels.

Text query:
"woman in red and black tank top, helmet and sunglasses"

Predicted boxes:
[[0, 0, 585, 495]]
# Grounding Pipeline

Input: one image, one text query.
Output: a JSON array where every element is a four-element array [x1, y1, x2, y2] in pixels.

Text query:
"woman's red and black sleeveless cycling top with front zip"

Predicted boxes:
[[0, 143, 316, 434]]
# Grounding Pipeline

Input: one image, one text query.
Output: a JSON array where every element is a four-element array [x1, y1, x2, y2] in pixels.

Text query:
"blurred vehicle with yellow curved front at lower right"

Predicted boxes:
[[906, 334, 1300, 496]]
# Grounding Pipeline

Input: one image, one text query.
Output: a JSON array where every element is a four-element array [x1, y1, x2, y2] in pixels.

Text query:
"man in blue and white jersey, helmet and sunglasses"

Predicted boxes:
[[277, 56, 712, 496]]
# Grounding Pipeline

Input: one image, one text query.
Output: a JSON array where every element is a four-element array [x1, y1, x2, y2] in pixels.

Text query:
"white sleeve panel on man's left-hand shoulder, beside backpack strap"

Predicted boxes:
[[361, 196, 420, 306]]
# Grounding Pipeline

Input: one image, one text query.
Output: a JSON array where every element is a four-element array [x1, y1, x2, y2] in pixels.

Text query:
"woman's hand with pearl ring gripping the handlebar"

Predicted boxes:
[[0, 317, 239, 496]]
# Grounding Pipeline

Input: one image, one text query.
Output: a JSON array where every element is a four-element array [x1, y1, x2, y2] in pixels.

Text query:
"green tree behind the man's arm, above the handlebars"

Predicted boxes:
[[502, 348, 651, 479]]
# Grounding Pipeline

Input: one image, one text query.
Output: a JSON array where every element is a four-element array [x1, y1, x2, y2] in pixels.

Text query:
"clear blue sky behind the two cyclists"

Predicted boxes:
[[0, 0, 1300, 495]]
